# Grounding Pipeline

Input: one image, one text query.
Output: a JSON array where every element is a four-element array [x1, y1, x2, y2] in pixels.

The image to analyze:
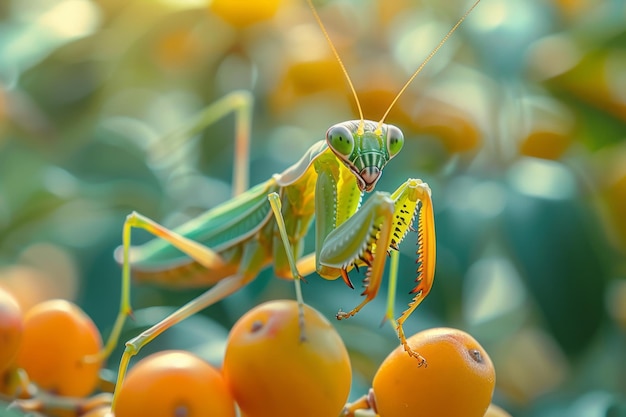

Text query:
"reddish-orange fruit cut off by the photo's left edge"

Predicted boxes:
[[0, 288, 24, 374]]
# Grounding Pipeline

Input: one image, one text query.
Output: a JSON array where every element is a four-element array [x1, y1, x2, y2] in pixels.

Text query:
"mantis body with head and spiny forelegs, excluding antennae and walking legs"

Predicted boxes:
[[133, 121, 435, 317]]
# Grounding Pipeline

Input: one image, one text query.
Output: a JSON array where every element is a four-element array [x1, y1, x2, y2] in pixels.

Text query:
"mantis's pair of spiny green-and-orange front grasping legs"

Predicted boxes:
[[318, 179, 436, 364]]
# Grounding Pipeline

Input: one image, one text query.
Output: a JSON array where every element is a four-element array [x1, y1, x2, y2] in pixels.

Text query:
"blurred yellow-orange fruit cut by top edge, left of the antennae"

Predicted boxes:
[[209, 0, 281, 27]]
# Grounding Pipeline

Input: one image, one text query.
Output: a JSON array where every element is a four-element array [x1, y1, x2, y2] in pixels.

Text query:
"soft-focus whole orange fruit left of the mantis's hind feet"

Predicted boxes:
[[16, 300, 102, 397]]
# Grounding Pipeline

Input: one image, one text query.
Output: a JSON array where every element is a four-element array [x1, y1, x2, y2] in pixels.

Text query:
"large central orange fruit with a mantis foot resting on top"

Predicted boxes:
[[222, 300, 352, 417]]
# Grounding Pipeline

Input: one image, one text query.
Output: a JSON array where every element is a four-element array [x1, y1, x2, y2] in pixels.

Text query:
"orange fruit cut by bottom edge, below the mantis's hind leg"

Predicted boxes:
[[114, 350, 236, 417]]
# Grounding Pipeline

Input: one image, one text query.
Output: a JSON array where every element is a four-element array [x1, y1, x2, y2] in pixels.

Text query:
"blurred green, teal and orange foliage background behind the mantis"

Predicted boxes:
[[0, 0, 626, 417]]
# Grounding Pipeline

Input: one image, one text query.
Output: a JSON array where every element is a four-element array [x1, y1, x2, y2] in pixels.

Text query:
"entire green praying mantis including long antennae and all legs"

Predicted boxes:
[[101, 0, 480, 404]]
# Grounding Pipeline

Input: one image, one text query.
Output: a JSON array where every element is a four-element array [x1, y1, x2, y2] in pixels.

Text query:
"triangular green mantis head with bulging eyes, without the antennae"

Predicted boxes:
[[326, 120, 404, 192]]
